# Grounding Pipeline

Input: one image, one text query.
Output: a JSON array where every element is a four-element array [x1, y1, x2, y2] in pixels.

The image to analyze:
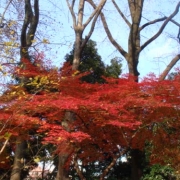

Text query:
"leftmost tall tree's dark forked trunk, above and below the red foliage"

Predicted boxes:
[[10, 0, 39, 180]]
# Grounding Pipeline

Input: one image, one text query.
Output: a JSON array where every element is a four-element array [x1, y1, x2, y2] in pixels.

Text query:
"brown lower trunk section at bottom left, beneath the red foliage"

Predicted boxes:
[[10, 138, 26, 180]]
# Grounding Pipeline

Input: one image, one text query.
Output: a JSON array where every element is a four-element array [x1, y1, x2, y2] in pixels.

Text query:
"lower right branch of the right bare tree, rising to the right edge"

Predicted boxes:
[[140, 2, 180, 51]]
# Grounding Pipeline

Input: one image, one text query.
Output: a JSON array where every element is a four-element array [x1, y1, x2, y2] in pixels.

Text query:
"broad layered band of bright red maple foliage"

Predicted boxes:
[[0, 57, 180, 169]]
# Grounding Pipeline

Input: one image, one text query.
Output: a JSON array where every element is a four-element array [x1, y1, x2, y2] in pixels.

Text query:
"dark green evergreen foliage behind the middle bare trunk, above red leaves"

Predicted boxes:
[[65, 40, 122, 83]]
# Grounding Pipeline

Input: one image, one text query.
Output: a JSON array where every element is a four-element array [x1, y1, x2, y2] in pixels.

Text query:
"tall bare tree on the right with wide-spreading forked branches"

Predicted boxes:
[[87, 0, 180, 79]]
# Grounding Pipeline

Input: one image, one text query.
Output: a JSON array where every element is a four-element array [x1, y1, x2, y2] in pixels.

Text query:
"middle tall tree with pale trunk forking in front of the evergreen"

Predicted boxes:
[[56, 0, 106, 176]]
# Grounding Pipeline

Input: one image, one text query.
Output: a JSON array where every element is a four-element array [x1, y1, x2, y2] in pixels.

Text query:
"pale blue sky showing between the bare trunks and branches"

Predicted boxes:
[[0, 0, 180, 77]]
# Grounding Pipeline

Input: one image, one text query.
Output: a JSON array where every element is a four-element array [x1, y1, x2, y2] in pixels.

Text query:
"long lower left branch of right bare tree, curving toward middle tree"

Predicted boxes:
[[86, 0, 127, 57]]
